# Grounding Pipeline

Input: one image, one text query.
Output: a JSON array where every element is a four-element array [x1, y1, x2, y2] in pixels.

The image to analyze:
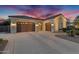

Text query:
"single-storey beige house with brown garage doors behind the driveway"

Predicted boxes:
[[9, 14, 67, 33]]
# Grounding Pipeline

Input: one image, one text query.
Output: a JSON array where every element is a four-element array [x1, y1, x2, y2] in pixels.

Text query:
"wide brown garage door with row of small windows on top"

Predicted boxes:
[[17, 22, 35, 32]]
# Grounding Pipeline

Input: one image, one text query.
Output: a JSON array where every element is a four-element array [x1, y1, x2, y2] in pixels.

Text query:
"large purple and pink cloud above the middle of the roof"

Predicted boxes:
[[16, 5, 61, 18]]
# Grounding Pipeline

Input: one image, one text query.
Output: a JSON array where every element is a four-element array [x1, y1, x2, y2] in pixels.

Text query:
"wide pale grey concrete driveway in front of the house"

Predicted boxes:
[[0, 32, 79, 54]]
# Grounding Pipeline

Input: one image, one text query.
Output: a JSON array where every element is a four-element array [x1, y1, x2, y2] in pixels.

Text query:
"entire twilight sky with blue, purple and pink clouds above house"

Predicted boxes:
[[0, 5, 79, 19]]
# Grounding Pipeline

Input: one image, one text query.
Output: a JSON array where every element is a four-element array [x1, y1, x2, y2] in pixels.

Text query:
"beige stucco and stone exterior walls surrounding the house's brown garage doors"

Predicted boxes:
[[10, 15, 67, 33]]
